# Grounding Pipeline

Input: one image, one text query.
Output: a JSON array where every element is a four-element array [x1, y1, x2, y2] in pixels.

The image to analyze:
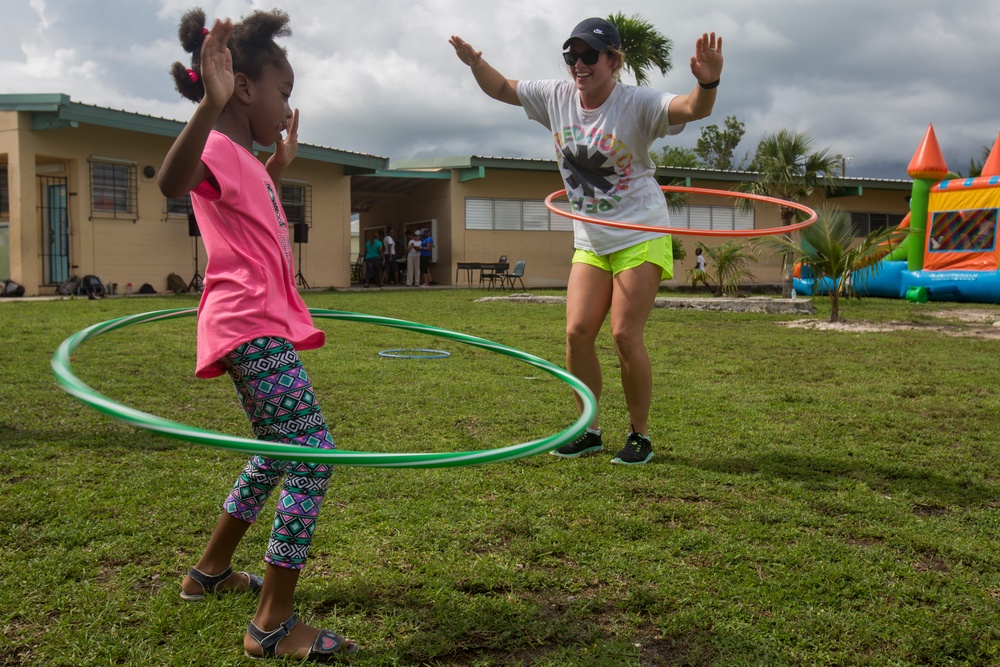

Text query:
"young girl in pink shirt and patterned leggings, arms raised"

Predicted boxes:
[[159, 9, 358, 662]]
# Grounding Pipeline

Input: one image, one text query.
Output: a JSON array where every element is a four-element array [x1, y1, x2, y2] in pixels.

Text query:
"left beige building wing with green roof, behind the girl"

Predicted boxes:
[[0, 94, 388, 295]]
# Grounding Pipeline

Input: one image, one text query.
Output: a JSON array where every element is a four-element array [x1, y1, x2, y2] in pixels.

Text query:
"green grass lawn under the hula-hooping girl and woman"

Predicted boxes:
[[0, 290, 1000, 667]]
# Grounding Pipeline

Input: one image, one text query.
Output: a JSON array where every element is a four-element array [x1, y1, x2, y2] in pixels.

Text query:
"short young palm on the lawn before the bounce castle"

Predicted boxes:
[[754, 205, 907, 322]]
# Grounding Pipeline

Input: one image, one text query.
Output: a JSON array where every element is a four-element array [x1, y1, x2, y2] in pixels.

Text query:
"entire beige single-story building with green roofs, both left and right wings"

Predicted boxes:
[[0, 94, 911, 295]]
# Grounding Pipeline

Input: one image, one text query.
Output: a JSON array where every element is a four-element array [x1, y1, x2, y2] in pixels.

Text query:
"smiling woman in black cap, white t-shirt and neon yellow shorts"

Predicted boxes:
[[449, 18, 722, 464]]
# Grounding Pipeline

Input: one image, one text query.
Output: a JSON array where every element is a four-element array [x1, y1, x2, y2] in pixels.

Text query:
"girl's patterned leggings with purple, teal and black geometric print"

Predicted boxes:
[[223, 338, 336, 570]]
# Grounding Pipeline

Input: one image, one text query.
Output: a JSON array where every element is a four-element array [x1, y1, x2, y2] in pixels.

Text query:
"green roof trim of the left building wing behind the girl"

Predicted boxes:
[[0, 93, 389, 173]]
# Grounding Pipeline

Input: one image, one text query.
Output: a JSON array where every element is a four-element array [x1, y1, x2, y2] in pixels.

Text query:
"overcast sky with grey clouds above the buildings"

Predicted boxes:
[[0, 0, 1000, 179]]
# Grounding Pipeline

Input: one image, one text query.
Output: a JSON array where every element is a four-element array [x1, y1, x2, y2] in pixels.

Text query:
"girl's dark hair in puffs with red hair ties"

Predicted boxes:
[[170, 8, 292, 102]]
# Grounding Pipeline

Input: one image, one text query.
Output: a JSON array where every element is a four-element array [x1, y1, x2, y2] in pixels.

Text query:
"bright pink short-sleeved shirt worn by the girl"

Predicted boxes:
[[191, 131, 326, 378]]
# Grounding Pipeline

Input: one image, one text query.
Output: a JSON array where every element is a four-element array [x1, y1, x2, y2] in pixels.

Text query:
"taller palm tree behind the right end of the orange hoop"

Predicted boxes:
[[737, 130, 840, 298]]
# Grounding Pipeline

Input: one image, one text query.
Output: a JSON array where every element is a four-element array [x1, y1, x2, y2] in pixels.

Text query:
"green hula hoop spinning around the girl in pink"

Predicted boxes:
[[52, 308, 597, 468]]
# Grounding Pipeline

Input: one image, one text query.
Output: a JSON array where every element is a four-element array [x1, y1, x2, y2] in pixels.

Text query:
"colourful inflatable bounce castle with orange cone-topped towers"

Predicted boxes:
[[794, 126, 1000, 303]]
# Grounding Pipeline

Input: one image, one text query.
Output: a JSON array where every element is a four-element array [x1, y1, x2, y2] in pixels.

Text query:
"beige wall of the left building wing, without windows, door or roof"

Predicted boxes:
[[0, 112, 350, 295]]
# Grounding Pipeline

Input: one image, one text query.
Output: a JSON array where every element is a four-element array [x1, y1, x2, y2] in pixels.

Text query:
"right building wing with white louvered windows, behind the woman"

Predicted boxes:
[[352, 156, 912, 287]]
